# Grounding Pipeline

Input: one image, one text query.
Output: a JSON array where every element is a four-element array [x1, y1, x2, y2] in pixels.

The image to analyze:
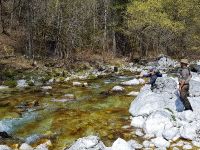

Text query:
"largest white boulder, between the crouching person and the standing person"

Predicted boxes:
[[129, 78, 184, 116]]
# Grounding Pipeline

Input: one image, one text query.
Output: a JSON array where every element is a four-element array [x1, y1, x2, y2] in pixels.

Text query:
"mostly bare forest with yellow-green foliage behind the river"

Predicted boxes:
[[0, 0, 200, 62]]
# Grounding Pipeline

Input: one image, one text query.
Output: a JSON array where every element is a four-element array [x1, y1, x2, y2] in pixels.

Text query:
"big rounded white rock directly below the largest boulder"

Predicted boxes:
[[144, 111, 171, 136]]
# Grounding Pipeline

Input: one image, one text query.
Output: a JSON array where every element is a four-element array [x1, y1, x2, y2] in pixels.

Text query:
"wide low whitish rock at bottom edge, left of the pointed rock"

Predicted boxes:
[[68, 136, 105, 150]]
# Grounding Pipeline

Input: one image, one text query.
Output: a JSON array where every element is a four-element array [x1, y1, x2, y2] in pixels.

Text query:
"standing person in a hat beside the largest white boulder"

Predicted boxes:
[[179, 59, 193, 111]]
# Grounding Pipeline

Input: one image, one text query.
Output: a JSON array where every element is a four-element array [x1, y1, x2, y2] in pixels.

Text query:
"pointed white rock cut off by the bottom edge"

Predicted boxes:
[[111, 138, 132, 150]]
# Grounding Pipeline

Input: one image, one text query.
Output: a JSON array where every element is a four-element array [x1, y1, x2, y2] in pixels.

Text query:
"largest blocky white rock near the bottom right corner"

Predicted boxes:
[[180, 124, 196, 140]]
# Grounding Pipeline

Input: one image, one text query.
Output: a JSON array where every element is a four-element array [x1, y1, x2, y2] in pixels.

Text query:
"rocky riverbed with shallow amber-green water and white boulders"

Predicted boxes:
[[0, 57, 200, 150]]
